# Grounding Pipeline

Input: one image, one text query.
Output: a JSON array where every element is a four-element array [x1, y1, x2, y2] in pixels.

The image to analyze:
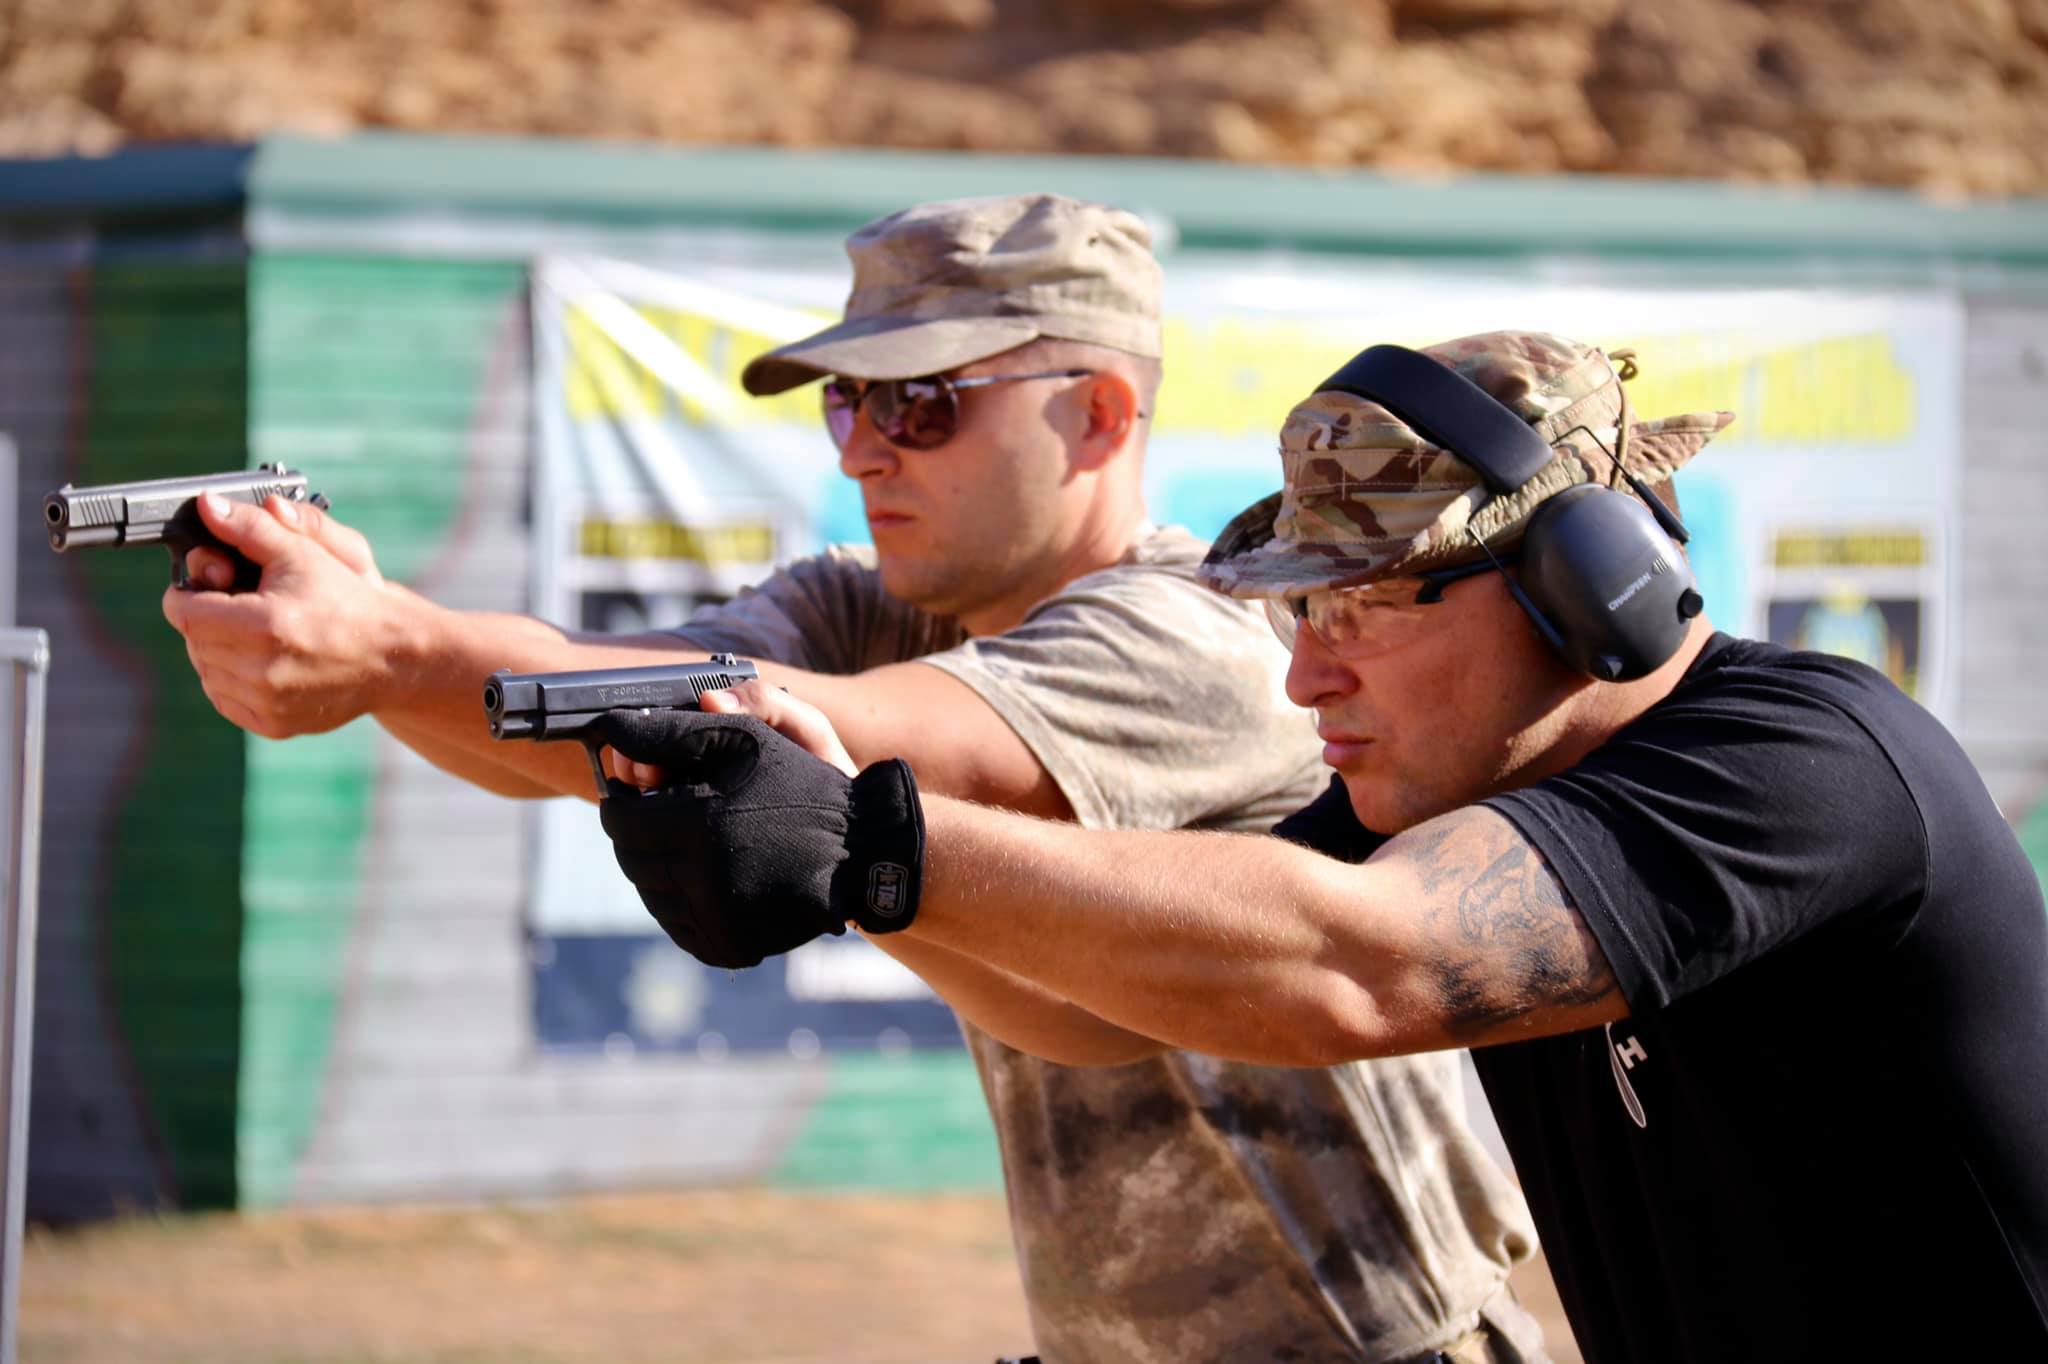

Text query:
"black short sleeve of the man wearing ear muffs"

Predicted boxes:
[[1487, 647, 1927, 1008]]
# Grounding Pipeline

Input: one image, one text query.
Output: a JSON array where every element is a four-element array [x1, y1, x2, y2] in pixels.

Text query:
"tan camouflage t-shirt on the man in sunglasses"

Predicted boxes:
[[680, 528, 1534, 1364]]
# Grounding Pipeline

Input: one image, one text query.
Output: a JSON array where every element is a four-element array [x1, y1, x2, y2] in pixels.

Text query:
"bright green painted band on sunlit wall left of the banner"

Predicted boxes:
[[240, 254, 526, 1204]]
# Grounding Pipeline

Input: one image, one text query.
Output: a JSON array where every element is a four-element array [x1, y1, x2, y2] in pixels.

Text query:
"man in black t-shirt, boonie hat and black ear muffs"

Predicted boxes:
[[598, 332, 2048, 1364]]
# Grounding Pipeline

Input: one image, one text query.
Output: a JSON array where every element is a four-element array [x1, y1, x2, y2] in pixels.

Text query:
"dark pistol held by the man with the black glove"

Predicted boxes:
[[483, 653, 760, 801]]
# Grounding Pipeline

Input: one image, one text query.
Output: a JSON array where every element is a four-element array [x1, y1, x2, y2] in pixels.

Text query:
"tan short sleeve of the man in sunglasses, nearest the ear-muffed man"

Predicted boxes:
[[922, 548, 1321, 829]]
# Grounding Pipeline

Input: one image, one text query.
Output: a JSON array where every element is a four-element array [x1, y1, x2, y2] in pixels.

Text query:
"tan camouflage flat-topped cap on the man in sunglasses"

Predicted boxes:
[[739, 195, 1159, 395]]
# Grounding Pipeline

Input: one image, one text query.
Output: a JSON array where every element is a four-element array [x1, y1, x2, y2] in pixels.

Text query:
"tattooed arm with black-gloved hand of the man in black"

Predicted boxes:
[[606, 682, 1628, 1065]]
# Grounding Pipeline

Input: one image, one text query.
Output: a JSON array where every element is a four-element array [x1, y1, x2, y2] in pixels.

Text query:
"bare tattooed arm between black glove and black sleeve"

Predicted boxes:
[[903, 799, 1628, 1065]]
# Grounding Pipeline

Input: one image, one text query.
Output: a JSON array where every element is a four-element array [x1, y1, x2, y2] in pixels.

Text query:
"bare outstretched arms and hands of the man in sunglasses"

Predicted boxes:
[[164, 498, 1071, 817]]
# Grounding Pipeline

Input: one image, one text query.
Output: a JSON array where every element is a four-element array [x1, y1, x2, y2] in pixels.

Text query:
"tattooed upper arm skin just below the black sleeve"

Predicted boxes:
[[1380, 809, 1616, 1042]]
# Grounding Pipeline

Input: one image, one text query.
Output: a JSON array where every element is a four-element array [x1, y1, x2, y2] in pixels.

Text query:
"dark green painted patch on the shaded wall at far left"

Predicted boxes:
[[80, 262, 248, 1206]]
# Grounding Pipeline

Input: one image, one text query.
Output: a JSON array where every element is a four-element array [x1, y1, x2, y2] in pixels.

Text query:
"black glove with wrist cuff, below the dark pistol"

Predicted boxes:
[[594, 711, 924, 969]]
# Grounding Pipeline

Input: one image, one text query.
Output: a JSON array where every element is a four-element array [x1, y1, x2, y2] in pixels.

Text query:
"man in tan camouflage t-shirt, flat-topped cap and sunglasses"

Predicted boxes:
[[166, 195, 1540, 1364]]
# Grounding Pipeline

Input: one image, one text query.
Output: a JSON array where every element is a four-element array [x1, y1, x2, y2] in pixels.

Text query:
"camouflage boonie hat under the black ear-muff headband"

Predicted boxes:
[[1196, 332, 1735, 598]]
